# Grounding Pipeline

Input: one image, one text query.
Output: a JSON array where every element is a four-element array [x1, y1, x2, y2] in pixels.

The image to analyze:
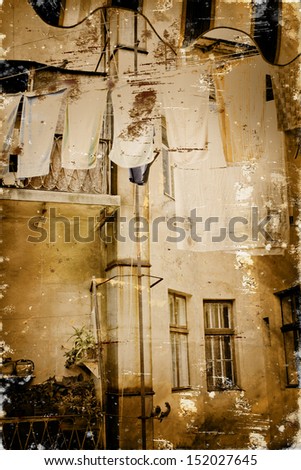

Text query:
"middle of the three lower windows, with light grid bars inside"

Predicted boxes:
[[204, 301, 237, 390]]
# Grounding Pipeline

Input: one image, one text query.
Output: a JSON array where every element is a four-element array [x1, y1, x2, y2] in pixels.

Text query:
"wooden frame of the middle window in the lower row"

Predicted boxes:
[[203, 299, 240, 392]]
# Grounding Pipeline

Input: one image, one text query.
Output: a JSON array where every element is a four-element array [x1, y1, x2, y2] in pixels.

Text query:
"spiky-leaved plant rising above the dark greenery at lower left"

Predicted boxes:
[[64, 326, 97, 368]]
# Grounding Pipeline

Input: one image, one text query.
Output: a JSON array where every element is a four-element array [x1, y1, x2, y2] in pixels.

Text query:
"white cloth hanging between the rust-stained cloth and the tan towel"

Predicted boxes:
[[159, 66, 210, 168]]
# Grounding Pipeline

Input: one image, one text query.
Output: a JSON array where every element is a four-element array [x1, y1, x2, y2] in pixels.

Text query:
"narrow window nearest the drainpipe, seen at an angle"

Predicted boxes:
[[168, 292, 189, 390]]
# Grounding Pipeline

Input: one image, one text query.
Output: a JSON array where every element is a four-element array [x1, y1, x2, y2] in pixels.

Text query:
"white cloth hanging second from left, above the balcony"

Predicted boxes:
[[17, 89, 65, 178]]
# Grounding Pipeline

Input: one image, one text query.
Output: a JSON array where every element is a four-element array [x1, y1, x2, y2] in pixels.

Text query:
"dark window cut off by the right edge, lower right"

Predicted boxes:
[[278, 286, 301, 387]]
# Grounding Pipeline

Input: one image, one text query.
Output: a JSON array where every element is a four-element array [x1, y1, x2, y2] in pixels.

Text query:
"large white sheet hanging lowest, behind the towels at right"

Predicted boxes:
[[171, 95, 289, 255]]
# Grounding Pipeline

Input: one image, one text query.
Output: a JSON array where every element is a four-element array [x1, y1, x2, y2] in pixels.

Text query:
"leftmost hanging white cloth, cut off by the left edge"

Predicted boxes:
[[0, 93, 22, 176]]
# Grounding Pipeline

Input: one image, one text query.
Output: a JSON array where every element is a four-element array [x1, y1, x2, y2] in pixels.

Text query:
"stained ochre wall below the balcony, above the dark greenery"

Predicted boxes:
[[2, 201, 102, 383]]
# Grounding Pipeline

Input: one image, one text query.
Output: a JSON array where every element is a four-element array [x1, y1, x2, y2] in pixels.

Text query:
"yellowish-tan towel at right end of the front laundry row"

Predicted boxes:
[[214, 56, 269, 163]]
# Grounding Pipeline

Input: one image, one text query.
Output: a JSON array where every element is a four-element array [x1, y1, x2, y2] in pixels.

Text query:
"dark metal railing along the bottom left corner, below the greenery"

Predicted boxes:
[[1, 415, 104, 450]]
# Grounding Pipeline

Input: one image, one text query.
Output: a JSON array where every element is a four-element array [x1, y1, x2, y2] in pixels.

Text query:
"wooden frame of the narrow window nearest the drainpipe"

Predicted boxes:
[[168, 290, 191, 392]]
